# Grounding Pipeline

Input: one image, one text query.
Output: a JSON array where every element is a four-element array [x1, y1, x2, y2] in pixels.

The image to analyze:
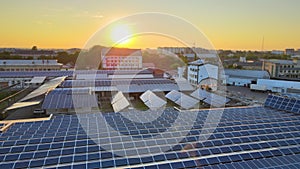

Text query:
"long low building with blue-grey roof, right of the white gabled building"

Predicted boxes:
[[223, 69, 270, 87]]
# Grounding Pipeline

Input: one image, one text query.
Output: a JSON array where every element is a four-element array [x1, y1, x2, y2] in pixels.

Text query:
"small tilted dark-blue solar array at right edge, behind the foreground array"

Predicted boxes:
[[265, 95, 300, 114]]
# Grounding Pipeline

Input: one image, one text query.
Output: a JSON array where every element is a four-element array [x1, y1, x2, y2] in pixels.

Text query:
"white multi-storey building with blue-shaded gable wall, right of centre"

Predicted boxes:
[[188, 59, 219, 90]]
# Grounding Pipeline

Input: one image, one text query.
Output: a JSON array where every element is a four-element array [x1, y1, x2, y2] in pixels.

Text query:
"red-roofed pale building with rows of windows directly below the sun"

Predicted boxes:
[[101, 48, 143, 70]]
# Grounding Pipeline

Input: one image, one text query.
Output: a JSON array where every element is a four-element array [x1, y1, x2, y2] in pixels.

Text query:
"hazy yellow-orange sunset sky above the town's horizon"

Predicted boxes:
[[0, 0, 300, 50]]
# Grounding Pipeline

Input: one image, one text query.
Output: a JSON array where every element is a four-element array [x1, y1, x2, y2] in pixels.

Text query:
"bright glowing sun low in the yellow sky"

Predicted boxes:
[[111, 25, 132, 47]]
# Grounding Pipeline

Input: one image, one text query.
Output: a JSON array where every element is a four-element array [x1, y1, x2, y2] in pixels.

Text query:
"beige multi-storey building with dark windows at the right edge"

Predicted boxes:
[[262, 59, 300, 80]]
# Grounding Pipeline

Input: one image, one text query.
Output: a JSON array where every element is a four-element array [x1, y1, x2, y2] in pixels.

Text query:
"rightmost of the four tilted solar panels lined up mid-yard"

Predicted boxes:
[[191, 89, 230, 107]]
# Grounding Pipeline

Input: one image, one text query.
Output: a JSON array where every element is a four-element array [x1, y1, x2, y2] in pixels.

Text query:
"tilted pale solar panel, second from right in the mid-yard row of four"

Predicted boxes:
[[166, 90, 199, 109]]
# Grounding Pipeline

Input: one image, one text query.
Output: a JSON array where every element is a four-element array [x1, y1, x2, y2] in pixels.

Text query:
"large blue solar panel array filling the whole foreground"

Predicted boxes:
[[0, 107, 300, 169]]
